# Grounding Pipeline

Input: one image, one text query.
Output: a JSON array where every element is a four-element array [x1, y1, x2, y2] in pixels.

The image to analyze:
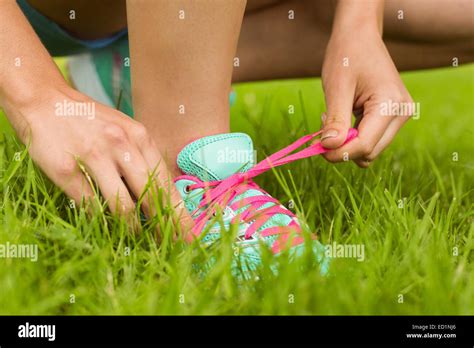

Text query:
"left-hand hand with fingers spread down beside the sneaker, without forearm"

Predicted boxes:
[[6, 87, 192, 227]]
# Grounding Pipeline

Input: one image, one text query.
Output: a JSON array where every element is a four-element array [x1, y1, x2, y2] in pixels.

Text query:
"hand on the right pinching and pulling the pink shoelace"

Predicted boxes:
[[321, 0, 413, 168]]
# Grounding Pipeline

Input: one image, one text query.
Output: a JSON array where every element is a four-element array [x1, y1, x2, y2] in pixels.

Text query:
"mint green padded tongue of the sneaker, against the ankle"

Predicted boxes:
[[177, 133, 255, 181]]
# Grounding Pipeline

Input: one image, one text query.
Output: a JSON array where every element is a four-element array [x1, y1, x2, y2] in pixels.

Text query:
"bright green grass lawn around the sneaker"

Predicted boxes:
[[0, 65, 474, 315]]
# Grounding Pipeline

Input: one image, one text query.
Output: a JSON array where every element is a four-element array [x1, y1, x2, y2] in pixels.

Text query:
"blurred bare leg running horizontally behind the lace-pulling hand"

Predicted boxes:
[[233, 0, 474, 82]]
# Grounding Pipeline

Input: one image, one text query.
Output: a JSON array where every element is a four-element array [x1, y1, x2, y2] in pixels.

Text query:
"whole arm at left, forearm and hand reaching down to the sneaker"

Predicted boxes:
[[0, 1, 191, 228]]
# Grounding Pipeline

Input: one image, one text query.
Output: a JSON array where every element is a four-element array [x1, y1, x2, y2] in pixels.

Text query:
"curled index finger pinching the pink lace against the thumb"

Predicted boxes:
[[323, 96, 395, 162]]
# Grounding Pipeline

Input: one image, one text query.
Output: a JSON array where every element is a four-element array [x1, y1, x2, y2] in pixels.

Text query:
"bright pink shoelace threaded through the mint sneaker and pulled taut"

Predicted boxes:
[[188, 128, 357, 253]]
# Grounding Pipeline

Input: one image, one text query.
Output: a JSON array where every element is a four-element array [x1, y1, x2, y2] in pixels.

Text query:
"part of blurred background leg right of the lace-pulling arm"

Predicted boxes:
[[384, 0, 474, 70]]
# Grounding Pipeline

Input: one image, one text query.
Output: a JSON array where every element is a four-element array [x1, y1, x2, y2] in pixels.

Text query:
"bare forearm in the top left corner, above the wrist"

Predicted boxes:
[[0, 0, 66, 123]]
